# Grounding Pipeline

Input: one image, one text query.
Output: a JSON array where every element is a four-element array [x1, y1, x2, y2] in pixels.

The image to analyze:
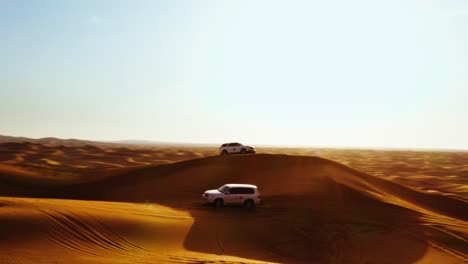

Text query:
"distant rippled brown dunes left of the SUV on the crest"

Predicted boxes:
[[0, 142, 216, 182]]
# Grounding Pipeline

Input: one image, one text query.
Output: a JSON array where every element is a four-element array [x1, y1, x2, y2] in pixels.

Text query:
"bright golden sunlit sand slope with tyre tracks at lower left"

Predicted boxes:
[[0, 197, 270, 263]]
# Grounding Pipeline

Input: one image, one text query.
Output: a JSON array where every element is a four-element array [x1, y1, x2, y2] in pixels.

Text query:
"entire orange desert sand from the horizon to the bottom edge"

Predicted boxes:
[[0, 140, 468, 264]]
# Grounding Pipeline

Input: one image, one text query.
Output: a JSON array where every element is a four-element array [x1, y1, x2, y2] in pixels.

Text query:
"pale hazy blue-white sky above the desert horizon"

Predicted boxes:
[[0, 0, 468, 149]]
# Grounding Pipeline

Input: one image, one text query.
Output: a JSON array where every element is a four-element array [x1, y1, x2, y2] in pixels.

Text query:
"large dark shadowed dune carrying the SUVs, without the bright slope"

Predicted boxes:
[[0, 154, 468, 263]]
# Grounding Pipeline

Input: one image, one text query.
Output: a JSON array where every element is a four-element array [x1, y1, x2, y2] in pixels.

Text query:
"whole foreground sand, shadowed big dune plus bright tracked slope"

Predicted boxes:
[[0, 154, 468, 263]]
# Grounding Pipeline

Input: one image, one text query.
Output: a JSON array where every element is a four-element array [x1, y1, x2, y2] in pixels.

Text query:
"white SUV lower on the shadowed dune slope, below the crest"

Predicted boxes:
[[202, 184, 260, 209]]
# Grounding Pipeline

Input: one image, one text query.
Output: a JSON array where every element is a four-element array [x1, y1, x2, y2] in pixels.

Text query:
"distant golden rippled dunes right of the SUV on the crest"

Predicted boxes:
[[262, 148, 468, 201]]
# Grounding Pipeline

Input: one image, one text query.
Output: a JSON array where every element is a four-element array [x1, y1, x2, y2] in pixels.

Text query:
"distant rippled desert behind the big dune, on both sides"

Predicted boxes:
[[0, 140, 468, 200]]
